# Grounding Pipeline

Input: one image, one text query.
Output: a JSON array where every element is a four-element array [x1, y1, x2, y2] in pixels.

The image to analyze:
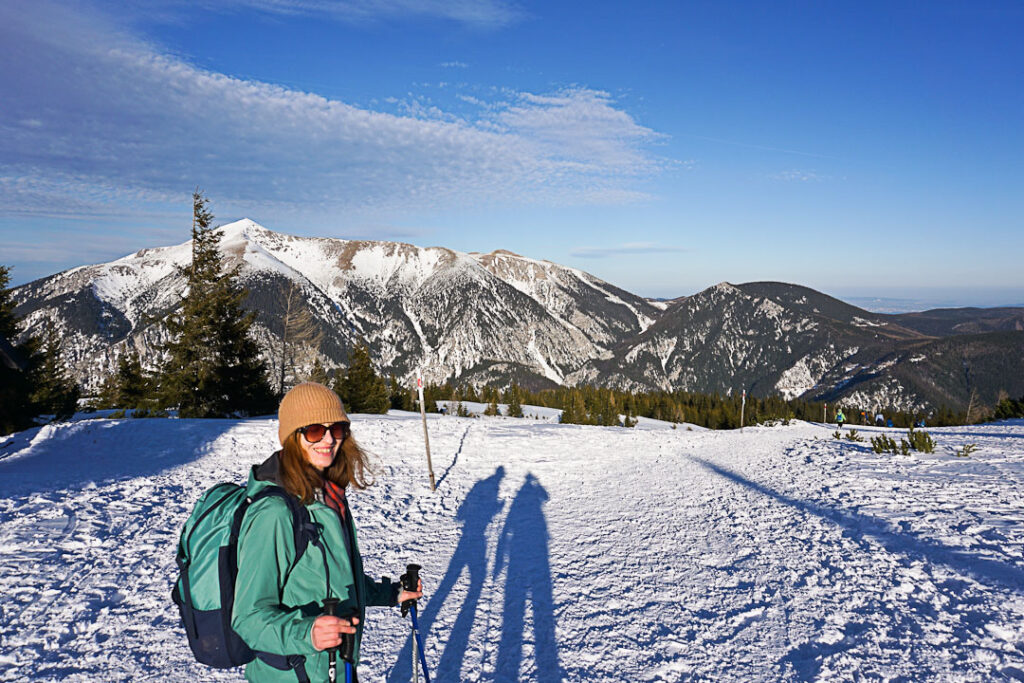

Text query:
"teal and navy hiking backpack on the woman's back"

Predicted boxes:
[[171, 483, 319, 679]]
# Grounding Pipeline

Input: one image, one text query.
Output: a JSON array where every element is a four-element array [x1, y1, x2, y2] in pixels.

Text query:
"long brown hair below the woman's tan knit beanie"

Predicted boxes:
[[281, 429, 373, 505]]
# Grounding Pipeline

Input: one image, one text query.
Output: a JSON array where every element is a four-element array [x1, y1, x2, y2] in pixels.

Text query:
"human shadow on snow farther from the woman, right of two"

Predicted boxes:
[[494, 474, 563, 683]]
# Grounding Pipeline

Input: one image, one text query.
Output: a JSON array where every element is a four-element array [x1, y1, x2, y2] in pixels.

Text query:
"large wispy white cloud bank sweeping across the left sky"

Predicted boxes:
[[0, 1, 663, 228]]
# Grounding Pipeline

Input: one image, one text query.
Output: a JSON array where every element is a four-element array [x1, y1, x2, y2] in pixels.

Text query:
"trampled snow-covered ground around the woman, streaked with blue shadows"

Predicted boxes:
[[0, 414, 1024, 682]]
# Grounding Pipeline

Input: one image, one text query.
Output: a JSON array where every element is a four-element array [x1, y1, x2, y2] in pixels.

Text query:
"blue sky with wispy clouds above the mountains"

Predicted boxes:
[[0, 0, 1024, 305]]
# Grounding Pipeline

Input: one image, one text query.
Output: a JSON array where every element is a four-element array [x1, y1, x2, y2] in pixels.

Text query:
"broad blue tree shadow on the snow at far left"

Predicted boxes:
[[0, 418, 243, 497]]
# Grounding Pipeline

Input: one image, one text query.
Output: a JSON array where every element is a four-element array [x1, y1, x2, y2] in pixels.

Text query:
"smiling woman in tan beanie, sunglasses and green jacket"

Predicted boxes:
[[231, 382, 423, 683]]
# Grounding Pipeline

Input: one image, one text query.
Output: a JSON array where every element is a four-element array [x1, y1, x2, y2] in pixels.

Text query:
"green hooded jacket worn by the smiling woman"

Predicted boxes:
[[231, 454, 399, 683]]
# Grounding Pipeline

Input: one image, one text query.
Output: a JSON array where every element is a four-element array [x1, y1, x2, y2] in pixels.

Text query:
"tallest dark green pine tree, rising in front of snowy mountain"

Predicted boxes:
[[160, 189, 274, 418]]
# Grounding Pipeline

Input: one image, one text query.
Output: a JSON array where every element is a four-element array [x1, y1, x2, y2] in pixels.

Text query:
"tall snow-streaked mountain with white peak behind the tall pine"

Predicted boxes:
[[9, 220, 660, 387]]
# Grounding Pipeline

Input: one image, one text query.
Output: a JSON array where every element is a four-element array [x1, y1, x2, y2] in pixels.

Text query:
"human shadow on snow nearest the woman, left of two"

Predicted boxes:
[[387, 466, 505, 683]]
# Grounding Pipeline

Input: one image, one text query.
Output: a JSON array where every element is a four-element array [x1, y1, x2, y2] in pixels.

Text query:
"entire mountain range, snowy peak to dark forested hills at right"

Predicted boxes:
[[13, 219, 1024, 410]]
